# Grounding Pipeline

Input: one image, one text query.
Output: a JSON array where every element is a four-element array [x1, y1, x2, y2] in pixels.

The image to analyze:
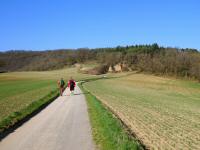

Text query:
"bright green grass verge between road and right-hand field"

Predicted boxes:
[[79, 84, 142, 150]]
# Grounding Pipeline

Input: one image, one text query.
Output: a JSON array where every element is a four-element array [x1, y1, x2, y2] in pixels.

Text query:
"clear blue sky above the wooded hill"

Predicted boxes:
[[0, 0, 200, 50]]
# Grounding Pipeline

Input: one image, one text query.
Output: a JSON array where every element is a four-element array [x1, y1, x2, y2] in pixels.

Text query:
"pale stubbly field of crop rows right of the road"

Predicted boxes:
[[84, 74, 200, 150]]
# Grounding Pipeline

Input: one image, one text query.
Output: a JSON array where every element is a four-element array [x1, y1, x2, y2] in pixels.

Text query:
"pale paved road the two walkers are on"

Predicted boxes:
[[0, 87, 95, 150]]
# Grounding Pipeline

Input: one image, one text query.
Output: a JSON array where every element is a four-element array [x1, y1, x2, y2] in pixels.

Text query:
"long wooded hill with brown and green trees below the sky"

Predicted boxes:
[[0, 44, 200, 80]]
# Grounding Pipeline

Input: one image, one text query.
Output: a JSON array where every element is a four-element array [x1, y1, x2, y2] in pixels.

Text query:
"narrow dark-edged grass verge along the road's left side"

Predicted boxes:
[[0, 90, 59, 135]]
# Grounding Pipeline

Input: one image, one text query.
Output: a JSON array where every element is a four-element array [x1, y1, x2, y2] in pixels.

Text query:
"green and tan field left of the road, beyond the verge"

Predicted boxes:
[[0, 67, 95, 127]]
